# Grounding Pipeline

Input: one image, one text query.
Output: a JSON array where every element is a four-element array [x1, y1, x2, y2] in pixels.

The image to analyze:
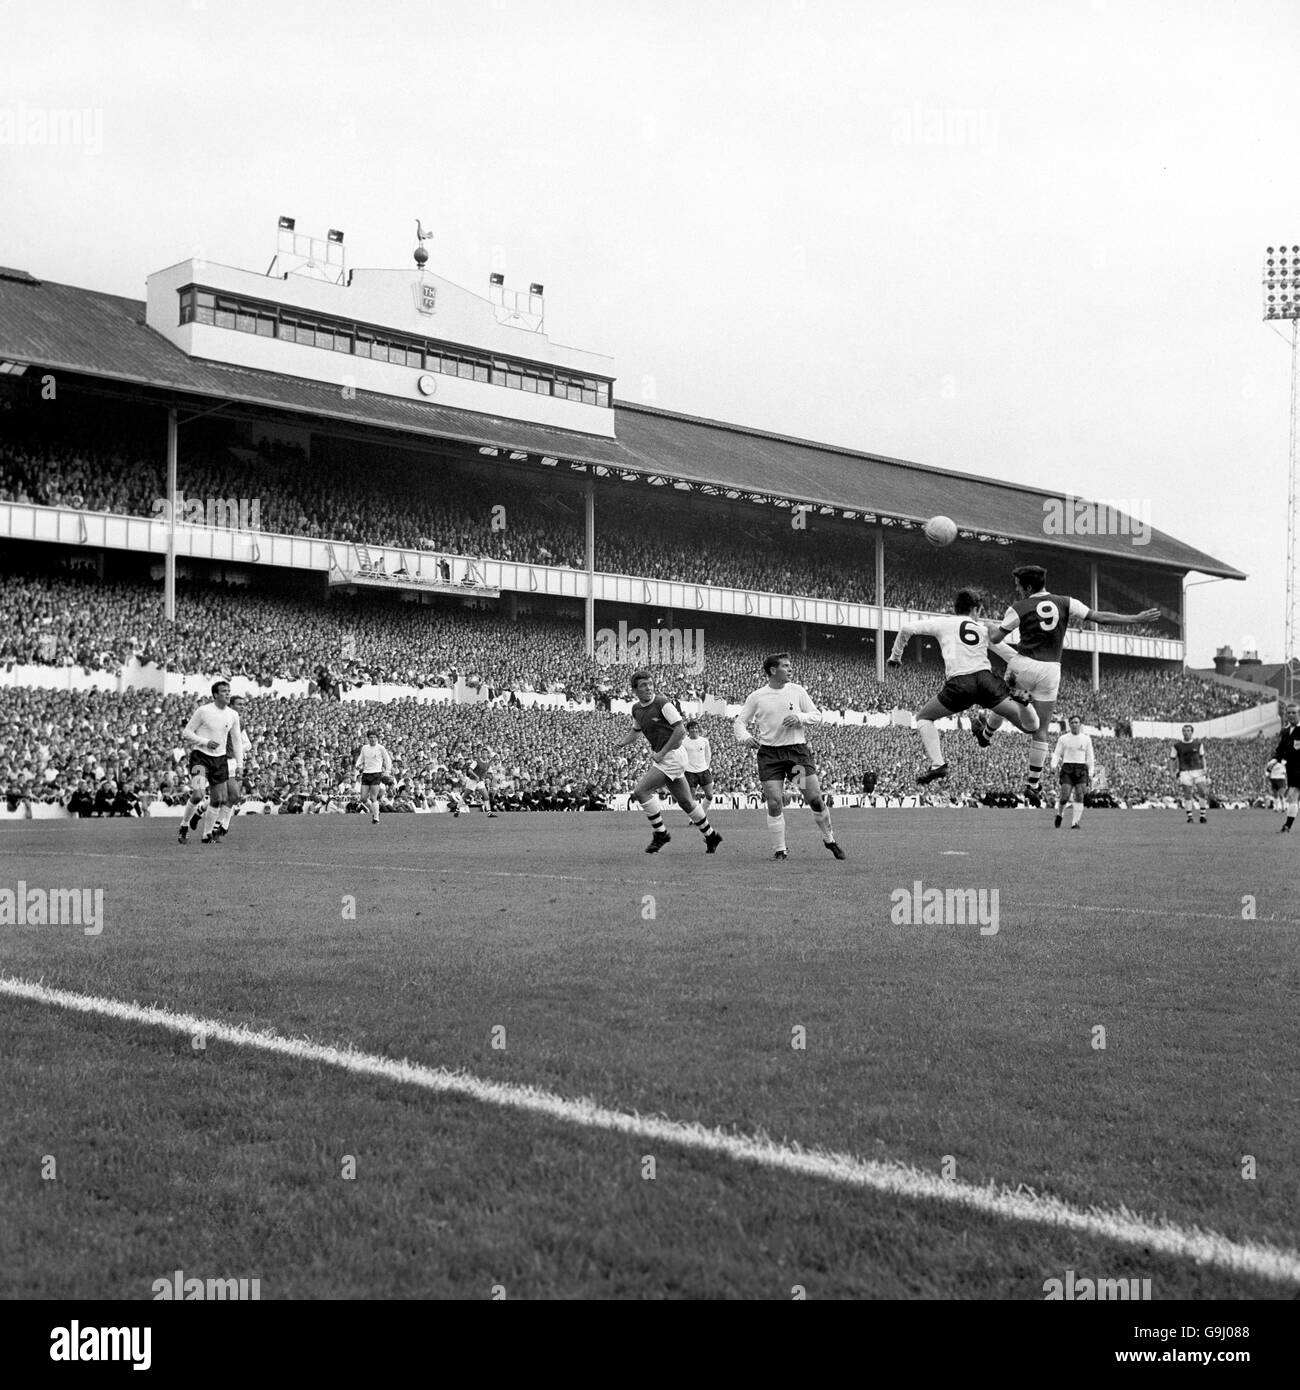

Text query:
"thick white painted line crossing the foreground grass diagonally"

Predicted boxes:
[[0, 976, 1300, 1284]]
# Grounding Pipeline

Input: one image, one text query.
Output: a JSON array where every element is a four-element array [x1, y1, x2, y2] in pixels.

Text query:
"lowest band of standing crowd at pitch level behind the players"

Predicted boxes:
[[0, 687, 1272, 815]]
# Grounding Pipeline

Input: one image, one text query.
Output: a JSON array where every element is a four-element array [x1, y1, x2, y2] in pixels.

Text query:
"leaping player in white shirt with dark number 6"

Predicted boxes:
[[886, 589, 1039, 783]]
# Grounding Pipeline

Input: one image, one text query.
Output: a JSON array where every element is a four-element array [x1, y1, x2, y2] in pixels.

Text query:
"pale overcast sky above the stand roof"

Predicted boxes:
[[0, 0, 1300, 666]]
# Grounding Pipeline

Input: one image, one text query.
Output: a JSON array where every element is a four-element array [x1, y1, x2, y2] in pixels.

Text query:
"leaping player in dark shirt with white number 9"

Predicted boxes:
[[984, 564, 1160, 806]]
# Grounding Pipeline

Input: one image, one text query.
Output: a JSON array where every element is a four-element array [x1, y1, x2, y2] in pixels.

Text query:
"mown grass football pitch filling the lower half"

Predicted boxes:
[[0, 809, 1300, 1300]]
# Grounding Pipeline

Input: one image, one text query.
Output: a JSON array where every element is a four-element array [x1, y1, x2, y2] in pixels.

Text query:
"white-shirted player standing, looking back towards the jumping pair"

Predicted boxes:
[[733, 652, 844, 859]]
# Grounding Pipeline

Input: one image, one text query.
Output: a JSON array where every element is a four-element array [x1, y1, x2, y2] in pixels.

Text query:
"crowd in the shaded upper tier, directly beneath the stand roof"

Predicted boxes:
[[0, 419, 1179, 622]]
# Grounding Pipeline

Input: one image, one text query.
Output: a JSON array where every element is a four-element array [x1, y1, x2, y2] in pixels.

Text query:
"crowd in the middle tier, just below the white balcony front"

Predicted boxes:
[[0, 575, 1262, 727]]
